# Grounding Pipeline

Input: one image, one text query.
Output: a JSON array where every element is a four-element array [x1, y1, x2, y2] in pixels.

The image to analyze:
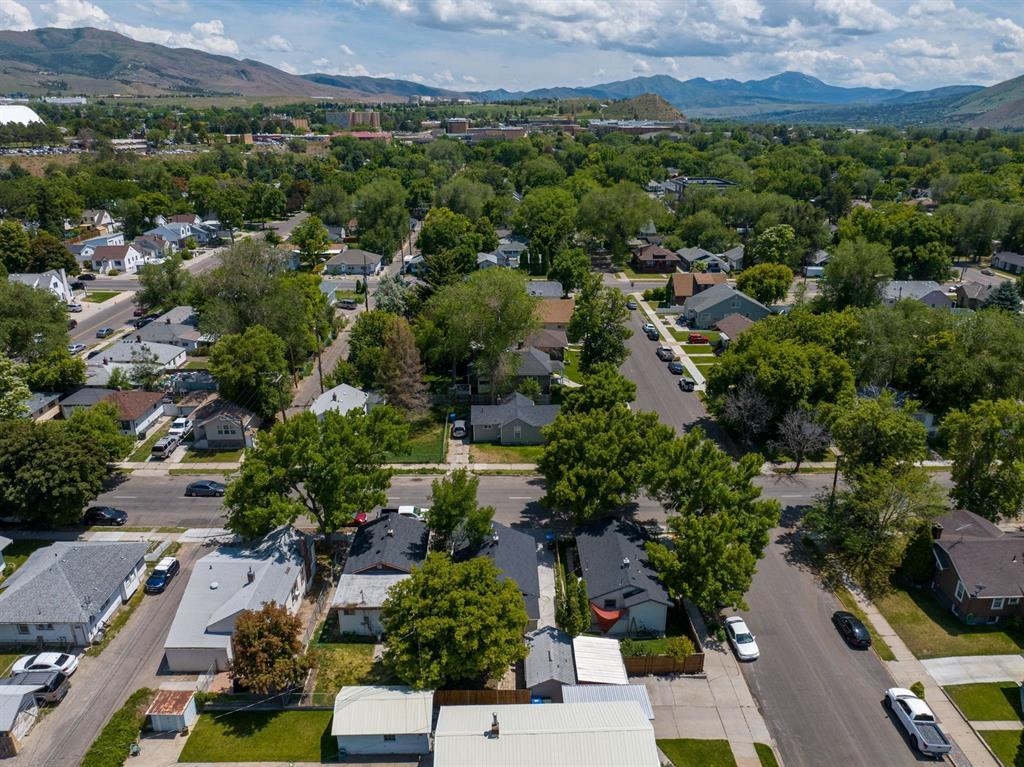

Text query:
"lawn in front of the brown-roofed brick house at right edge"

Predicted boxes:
[[874, 588, 1024, 658]]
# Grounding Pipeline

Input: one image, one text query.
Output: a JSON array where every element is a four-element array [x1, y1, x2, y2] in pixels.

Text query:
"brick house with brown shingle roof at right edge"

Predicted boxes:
[[932, 511, 1024, 625]]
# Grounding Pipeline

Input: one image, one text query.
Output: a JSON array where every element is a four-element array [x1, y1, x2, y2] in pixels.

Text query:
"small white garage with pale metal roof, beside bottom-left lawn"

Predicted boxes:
[[331, 686, 434, 757]]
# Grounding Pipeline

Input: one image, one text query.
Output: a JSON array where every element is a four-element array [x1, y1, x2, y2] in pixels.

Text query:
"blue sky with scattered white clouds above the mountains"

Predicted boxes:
[[0, 0, 1024, 91]]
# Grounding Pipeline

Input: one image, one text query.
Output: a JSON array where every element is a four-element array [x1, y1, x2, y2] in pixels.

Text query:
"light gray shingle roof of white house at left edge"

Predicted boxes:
[[0, 541, 150, 624]]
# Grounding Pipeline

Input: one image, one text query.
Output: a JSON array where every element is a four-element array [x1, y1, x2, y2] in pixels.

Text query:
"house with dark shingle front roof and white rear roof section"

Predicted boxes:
[[331, 514, 428, 636]]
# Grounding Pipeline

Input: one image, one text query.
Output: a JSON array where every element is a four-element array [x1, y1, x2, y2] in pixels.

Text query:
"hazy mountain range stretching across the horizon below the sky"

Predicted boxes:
[[0, 28, 1024, 128]]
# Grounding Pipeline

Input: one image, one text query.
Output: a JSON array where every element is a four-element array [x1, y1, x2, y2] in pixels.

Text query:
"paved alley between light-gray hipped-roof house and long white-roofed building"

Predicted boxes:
[[10, 546, 206, 767]]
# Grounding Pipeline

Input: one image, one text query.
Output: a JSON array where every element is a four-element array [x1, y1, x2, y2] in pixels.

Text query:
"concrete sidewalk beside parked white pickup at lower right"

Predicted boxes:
[[850, 589, 999, 767]]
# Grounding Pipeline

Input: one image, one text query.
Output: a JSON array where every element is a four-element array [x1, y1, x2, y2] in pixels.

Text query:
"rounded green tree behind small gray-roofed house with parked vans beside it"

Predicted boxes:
[[210, 325, 291, 420]]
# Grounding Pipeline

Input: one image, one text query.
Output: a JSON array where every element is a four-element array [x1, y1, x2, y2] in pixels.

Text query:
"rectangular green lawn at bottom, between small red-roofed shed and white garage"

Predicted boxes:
[[178, 711, 338, 762]]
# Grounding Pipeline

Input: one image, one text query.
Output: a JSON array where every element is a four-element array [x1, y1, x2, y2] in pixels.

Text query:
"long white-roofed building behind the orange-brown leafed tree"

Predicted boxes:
[[164, 525, 316, 674]]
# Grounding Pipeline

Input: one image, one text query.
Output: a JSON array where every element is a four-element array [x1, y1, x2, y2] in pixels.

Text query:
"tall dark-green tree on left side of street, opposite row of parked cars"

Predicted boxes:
[[567, 274, 633, 372]]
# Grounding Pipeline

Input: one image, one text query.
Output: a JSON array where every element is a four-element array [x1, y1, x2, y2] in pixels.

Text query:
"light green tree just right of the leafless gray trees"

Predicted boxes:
[[826, 391, 928, 469]]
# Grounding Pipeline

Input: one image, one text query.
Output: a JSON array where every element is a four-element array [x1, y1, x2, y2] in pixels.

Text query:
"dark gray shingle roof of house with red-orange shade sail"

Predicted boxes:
[[575, 519, 671, 607]]
